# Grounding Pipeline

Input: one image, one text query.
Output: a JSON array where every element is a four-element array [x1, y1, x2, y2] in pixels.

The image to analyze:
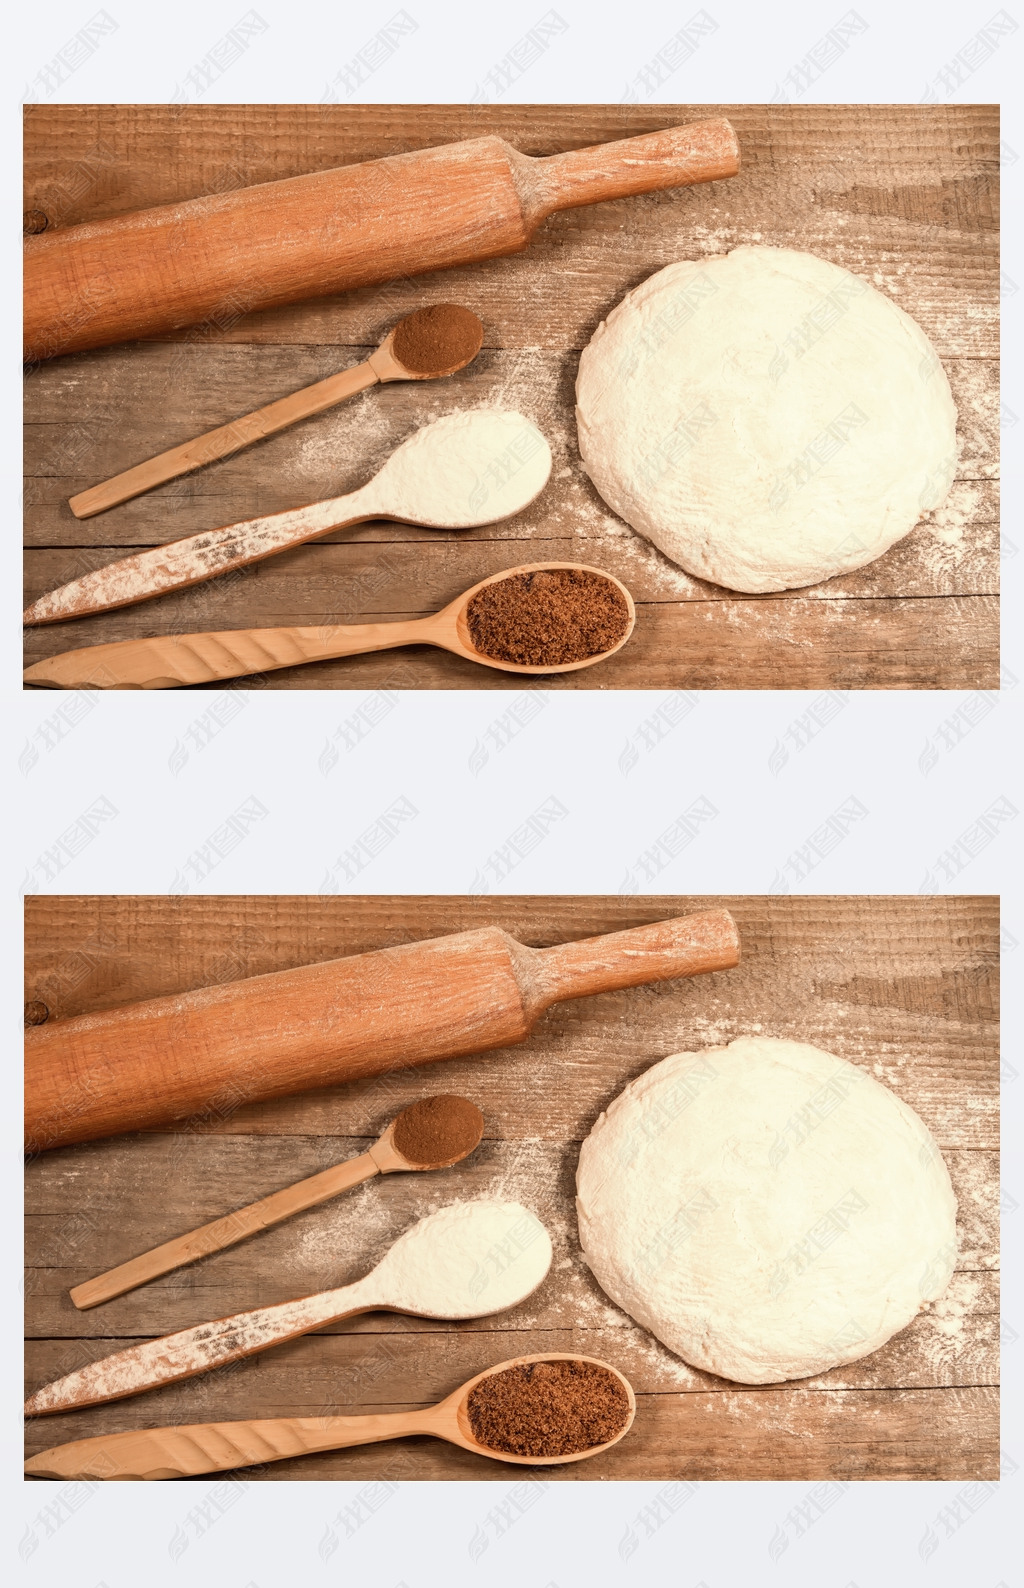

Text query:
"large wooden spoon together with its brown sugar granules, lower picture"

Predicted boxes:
[[25, 1351, 637, 1480]]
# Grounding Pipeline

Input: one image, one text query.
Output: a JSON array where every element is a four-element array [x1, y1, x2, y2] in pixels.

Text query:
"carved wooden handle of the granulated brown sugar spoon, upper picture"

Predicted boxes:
[[24, 618, 433, 689]]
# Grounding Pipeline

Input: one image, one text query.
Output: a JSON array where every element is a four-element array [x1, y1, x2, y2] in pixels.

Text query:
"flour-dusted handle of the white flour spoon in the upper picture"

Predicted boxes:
[[22, 495, 366, 626]]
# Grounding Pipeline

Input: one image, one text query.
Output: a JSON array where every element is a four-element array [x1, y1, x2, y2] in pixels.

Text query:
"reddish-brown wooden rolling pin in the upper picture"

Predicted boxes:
[[25, 121, 740, 360]]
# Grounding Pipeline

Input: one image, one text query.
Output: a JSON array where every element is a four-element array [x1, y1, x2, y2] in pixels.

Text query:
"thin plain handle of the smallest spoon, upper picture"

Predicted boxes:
[[68, 364, 378, 518]]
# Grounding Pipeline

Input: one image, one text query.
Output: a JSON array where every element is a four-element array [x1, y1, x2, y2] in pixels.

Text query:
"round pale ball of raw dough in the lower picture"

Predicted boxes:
[[576, 1037, 956, 1385]]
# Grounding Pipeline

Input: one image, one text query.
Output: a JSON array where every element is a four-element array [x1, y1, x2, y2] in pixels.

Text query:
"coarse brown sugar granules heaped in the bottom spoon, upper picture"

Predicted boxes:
[[465, 569, 629, 667]]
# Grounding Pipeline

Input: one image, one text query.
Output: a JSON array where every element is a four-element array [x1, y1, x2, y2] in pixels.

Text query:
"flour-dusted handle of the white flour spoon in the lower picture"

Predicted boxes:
[[25, 1280, 369, 1416]]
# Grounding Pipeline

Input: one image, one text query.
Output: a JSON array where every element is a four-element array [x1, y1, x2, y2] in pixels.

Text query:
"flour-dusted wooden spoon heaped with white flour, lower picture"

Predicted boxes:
[[25, 1202, 551, 1416]]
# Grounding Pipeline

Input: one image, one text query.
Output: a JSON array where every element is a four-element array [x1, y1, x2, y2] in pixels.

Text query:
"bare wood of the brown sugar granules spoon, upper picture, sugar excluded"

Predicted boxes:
[[24, 562, 637, 689]]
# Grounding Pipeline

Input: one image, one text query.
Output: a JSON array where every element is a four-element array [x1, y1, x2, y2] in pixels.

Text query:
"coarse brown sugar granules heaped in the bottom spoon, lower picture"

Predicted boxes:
[[467, 1359, 629, 1456]]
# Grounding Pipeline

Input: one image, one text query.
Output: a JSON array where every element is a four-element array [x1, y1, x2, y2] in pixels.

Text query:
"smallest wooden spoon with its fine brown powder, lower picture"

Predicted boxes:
[[70, 1094, 484, 1310]]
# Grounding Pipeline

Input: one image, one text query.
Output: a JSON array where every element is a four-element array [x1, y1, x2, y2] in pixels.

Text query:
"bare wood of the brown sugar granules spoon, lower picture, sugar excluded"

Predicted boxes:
[[25, 1351, 637, 1480]]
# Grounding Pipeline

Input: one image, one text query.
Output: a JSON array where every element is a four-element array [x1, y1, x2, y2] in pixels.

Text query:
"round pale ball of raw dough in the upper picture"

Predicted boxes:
[[576, 248, 956, 591]]
